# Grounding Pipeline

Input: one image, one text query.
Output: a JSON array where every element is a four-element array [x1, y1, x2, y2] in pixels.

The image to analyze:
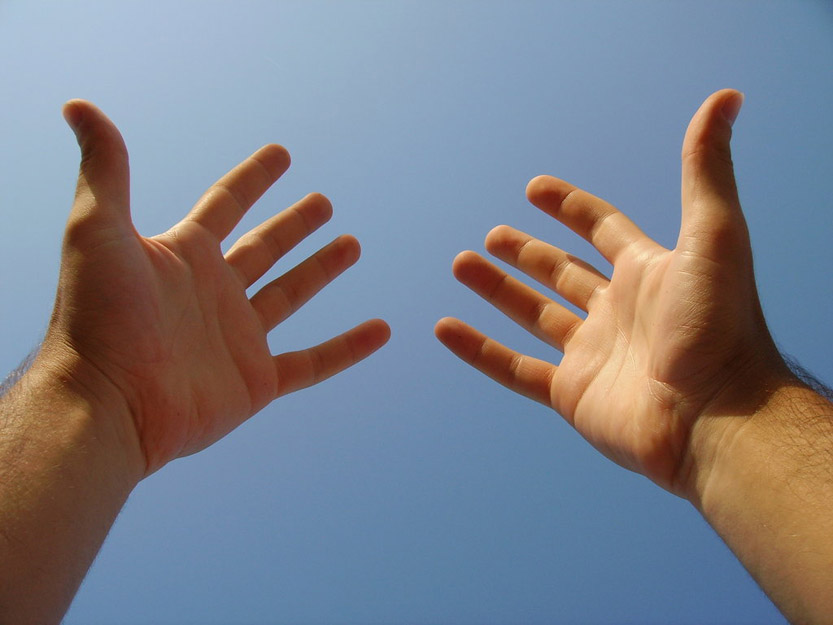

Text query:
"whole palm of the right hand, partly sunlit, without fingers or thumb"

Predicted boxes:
[[551, 248, 736, 487]]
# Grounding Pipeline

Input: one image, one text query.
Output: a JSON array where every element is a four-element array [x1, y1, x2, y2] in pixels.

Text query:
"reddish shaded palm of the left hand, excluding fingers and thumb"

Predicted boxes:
[[65, 223, 276, 462]]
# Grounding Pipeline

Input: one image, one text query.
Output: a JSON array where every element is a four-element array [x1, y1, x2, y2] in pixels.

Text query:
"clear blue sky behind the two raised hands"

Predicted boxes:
[[0, 0, 833, 625]]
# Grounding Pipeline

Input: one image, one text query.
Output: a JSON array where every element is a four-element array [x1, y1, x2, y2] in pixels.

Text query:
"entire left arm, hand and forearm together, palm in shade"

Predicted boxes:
[[0, 101, 390, 623]]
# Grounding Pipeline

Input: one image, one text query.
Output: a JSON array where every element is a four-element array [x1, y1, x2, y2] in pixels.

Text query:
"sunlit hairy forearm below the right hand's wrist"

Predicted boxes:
[[692, 380, 833, 624]]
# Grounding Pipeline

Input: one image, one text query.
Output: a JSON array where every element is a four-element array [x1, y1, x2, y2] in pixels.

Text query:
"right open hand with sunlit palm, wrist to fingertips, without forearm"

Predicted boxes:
[[436, 90, 790, 498]]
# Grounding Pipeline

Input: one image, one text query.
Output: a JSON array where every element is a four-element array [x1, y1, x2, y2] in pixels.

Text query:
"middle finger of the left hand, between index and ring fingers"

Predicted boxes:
[[226, 193, 333, 288]]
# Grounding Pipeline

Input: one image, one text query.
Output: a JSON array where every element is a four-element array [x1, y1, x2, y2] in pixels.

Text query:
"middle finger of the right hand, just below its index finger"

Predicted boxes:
[[486, 226, 609, 311]]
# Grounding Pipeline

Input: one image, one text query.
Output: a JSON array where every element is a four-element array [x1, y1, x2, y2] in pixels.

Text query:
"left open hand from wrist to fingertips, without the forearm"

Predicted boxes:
[[39, 101, 389, 475]]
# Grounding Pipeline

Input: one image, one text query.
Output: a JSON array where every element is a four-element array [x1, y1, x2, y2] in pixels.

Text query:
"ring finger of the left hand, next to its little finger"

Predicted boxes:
[[251, 234, 361, 332]]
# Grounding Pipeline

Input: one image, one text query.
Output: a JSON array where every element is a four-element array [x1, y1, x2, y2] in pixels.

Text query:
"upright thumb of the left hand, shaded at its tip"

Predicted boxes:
[[63, 100, 130, 224]]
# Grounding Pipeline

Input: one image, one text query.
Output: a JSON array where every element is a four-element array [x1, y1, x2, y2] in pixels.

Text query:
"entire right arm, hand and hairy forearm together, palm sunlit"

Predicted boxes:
[[435, 90, 833, 623]]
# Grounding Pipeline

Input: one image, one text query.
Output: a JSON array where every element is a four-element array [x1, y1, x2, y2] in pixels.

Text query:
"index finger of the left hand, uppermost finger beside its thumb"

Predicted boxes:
[[186, 145, 289, 241]]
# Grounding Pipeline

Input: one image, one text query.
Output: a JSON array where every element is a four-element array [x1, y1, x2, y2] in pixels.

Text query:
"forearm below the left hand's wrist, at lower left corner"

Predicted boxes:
[[0, 358, 140, 624]]
